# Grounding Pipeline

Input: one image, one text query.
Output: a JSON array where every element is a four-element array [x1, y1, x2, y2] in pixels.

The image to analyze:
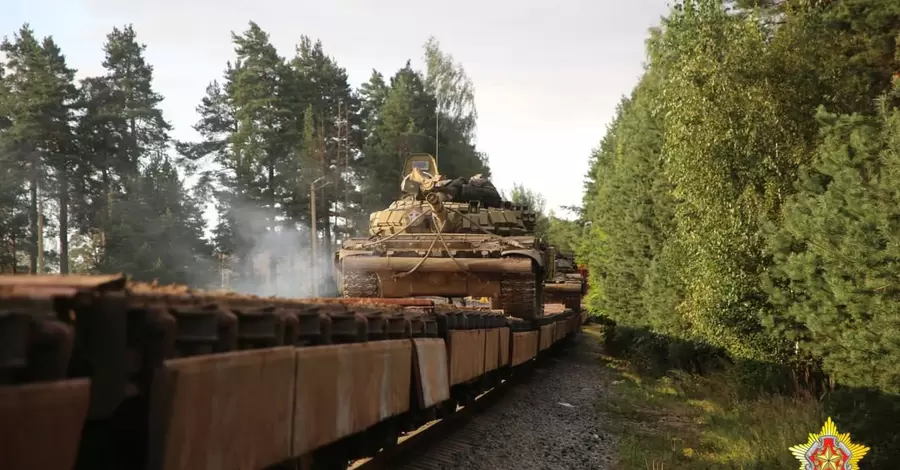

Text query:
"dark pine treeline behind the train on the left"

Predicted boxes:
[[0, 22, 489, 294]]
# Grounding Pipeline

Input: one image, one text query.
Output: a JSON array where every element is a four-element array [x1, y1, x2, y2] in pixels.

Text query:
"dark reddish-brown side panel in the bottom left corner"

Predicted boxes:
[[0, 379, 90, 470]]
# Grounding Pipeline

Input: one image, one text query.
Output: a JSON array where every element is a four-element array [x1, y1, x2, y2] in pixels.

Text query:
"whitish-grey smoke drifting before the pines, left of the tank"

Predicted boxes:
[[211, 203, 337, 298]]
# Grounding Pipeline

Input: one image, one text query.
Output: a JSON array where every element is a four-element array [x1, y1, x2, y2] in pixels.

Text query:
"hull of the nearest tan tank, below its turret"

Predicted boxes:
[[335, 233, 544, 318]]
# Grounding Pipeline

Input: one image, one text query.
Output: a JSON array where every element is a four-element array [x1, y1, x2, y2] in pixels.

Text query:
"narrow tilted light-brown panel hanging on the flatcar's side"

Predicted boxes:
[[412, 338, 450, 409]]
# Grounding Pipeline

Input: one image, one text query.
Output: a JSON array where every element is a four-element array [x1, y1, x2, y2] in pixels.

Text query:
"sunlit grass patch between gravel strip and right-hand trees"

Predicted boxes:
[[585, 325, 825, 470]]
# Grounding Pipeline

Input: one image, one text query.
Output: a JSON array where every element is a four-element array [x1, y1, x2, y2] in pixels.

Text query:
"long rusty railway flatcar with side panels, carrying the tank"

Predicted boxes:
[[0, 275, 583, 470]]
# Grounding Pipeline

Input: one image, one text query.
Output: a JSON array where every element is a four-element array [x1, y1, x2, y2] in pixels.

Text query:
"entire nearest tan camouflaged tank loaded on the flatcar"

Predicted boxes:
[[335, 154, 548, 319]]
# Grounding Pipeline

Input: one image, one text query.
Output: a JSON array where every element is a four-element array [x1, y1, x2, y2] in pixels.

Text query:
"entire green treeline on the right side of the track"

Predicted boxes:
[[579, 0, 900, 462]]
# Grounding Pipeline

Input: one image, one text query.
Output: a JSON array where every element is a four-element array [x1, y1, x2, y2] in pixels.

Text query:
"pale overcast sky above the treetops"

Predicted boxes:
[[0, 0, 668, 217]]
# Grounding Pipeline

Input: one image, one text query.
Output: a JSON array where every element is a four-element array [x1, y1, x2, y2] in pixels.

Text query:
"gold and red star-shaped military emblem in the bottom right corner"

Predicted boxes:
[[789, 417, 869, 470]]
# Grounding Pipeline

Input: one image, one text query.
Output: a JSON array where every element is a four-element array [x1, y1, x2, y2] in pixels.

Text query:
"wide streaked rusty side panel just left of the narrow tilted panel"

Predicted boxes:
[[292, 340, 412, 456]]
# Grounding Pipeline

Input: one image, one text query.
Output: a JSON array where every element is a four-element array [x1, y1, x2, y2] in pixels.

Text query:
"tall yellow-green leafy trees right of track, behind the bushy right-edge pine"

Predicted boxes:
[[579, 0, 900, 378]]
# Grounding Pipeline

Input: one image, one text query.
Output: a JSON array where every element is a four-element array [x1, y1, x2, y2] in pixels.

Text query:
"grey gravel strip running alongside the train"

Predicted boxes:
[[403, 334, 615, 470]]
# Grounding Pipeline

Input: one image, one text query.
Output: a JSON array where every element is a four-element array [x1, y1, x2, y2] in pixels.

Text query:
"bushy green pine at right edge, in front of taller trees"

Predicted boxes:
[[768, 89, 900, 394]]
